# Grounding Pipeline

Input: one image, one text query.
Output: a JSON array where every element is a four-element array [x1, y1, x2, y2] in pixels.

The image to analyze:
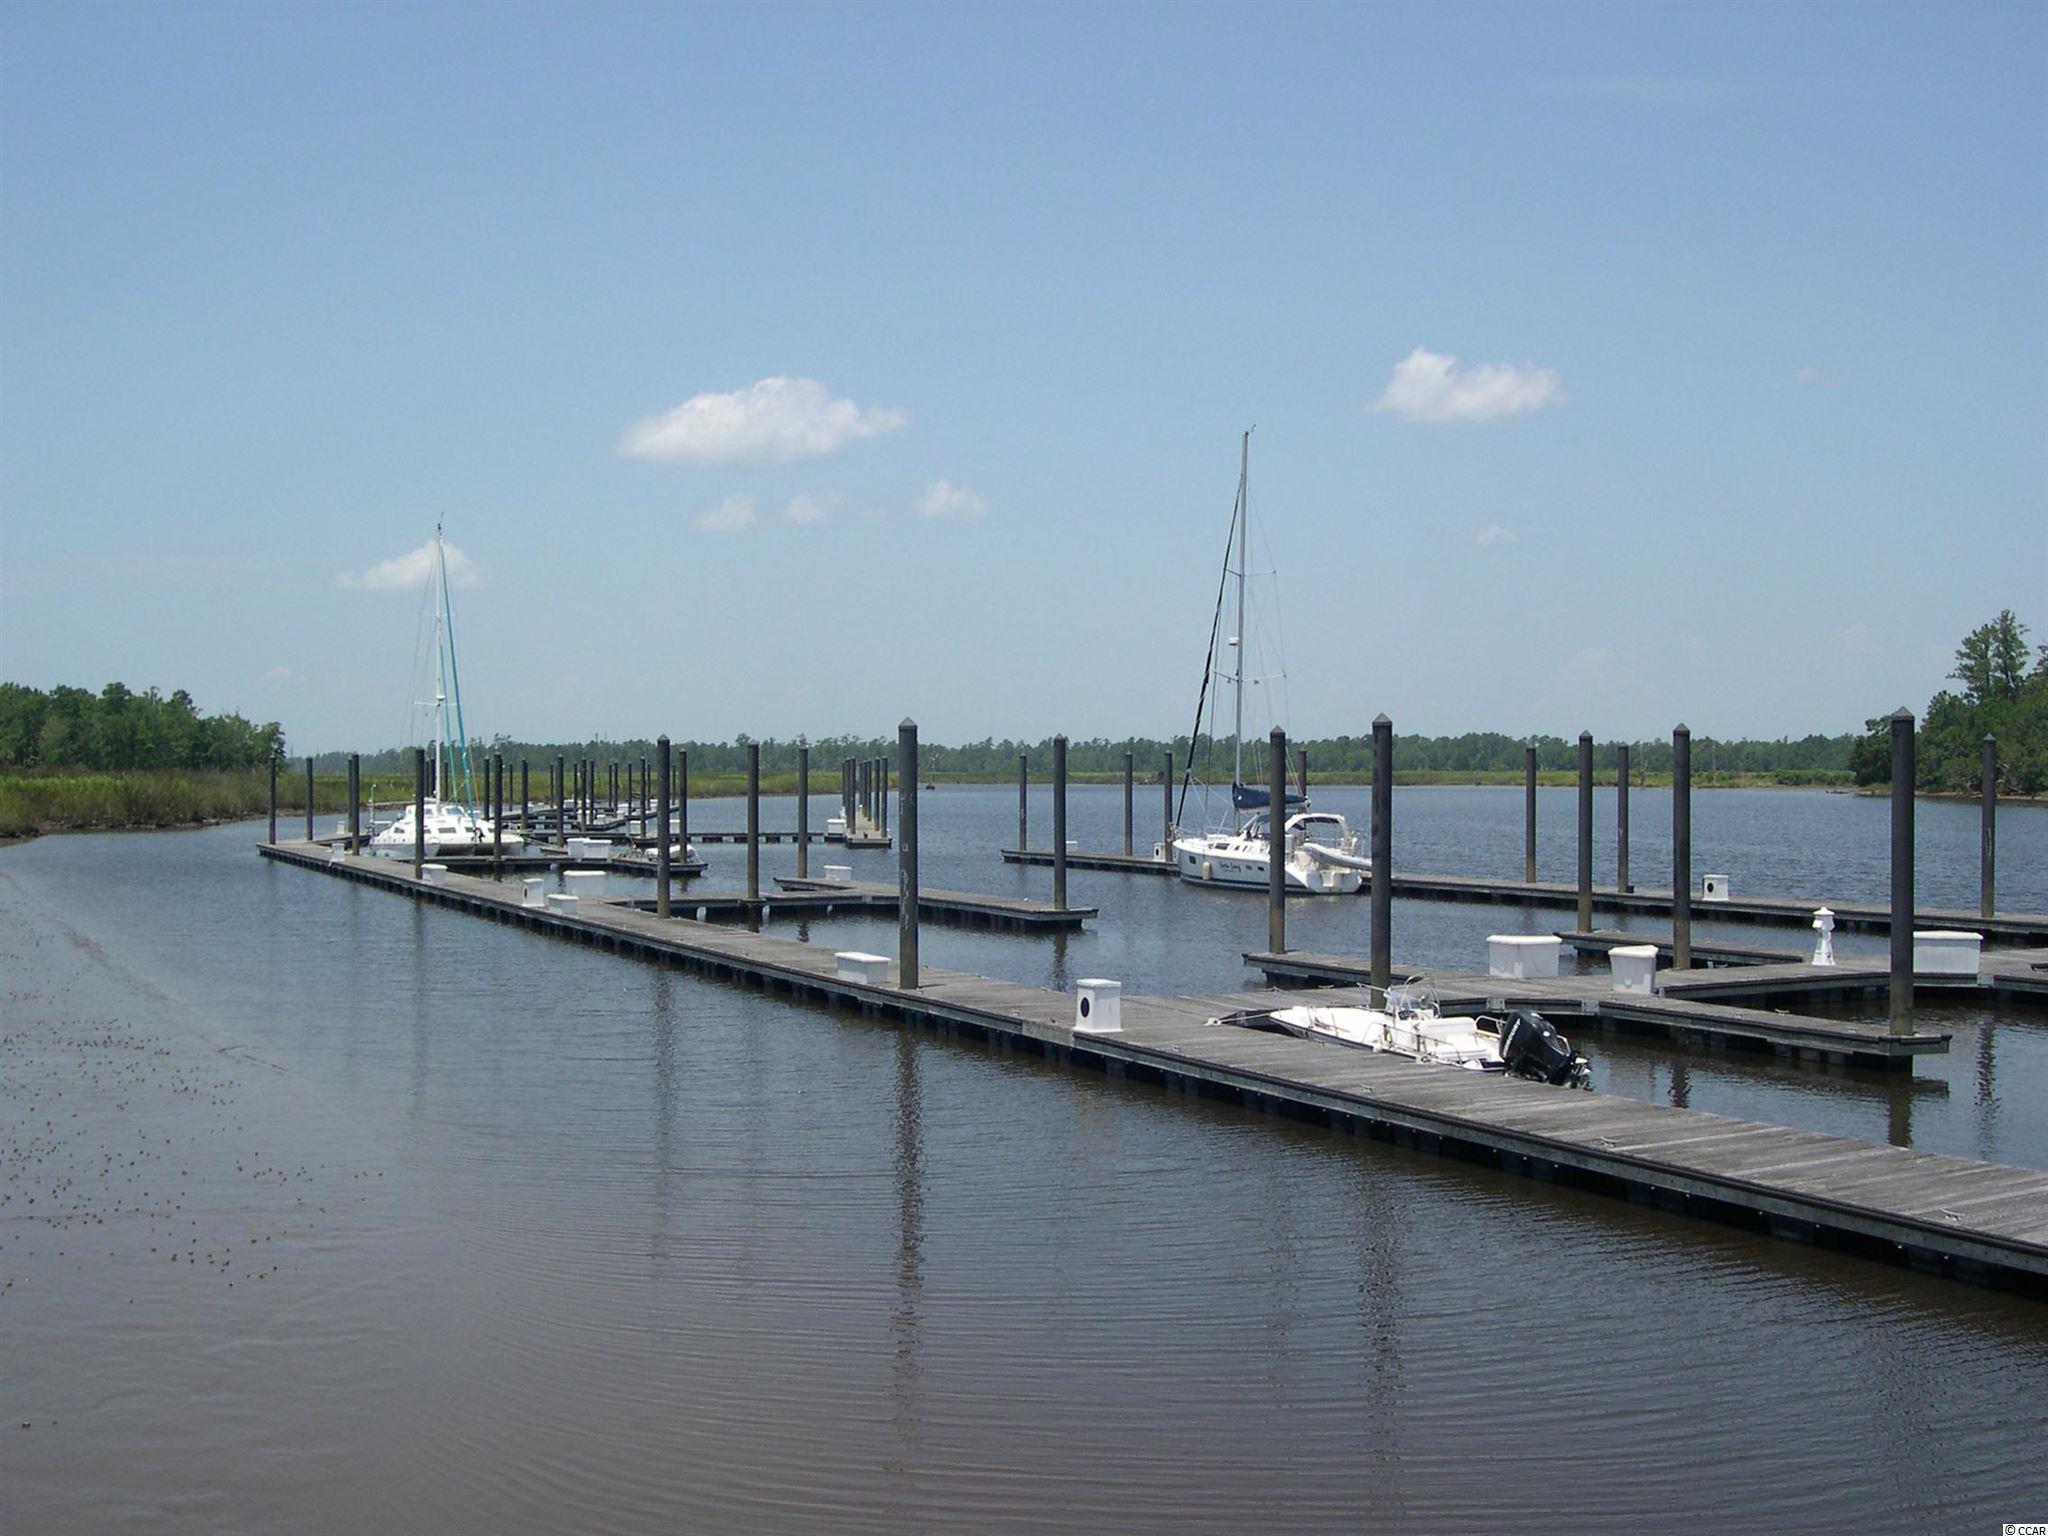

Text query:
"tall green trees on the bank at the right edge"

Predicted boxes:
[[1849, 608, 2048, 795]]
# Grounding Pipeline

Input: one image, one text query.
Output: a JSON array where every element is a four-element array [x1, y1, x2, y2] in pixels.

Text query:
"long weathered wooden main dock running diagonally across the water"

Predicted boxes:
[[260, 842, 2048, 1294]]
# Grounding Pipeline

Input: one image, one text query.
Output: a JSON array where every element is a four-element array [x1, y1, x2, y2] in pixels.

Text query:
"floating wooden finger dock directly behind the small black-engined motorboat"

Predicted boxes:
[[1245, 950, 1950, 1067]]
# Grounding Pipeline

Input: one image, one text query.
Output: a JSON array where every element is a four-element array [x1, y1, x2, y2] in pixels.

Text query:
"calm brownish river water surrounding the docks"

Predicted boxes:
[[0, 788, 2048, 1532]]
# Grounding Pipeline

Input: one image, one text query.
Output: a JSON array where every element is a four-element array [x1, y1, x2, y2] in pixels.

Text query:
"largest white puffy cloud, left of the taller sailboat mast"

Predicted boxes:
[[618, 377, 909, 465]]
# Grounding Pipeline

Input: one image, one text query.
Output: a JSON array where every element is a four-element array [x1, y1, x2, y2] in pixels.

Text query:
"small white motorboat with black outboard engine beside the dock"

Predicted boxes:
[[1208, 981, 1593, 1087]]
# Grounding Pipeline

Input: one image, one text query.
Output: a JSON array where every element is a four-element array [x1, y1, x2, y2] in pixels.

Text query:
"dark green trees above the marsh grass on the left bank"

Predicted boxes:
[[0, 682, 285, 772]]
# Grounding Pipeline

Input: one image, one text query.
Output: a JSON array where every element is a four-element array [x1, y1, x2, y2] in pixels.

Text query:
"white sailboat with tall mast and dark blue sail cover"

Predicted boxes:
[[1159, 432, 1372, 895]]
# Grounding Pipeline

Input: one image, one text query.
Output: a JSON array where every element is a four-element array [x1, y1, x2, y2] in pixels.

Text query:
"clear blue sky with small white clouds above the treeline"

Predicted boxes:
[[0, 4, 2048, 750]]
